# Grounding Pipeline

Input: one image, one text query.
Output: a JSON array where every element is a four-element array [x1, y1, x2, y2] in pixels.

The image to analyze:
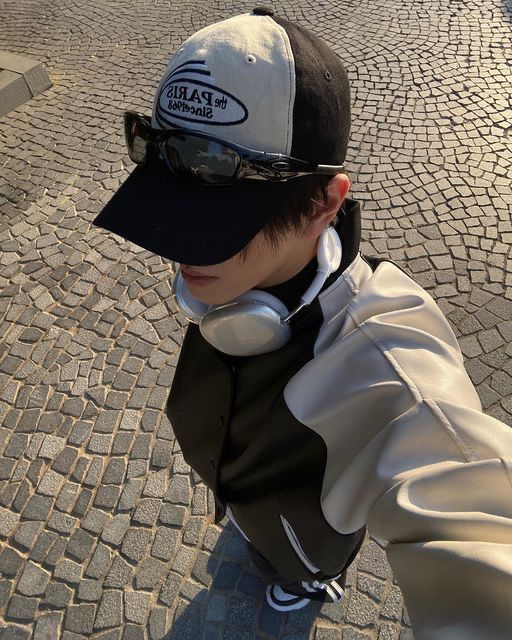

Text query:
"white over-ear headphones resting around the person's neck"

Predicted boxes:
[[172, 226, 341, 356]]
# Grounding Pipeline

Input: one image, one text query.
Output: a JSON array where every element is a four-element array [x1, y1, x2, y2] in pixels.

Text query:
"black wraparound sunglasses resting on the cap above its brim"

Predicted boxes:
[[124, 111, 344, 186]]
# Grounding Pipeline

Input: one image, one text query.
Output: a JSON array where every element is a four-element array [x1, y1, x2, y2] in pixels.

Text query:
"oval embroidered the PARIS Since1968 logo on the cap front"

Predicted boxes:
[[156, 74, 249, 126]]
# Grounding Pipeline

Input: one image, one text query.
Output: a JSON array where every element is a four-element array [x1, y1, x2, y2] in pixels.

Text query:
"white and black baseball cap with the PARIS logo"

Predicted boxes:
[[92, 7, 350, 266]]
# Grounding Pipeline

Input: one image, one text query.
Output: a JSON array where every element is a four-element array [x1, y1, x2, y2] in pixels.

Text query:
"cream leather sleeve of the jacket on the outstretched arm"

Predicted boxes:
[[286, 265, 512, 640]]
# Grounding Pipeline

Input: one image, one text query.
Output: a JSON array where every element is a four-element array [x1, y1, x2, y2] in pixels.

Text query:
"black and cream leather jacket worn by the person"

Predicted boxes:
[[167, 202, 512, 640]]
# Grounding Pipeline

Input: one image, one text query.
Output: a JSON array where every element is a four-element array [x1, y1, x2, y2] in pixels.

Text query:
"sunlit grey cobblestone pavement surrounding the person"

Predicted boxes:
[[0, 0, 512, 640]]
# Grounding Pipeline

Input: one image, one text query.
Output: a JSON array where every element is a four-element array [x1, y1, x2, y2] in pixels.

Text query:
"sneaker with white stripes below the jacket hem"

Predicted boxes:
[[266, 574, 345, 611]]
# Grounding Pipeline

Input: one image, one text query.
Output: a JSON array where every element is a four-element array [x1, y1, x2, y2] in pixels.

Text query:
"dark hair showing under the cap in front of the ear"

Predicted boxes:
[[240, 175, 332, 260]]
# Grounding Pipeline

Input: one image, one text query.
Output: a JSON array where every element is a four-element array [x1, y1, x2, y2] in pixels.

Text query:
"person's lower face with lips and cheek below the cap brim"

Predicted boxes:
[[180, 222, 317, 304]]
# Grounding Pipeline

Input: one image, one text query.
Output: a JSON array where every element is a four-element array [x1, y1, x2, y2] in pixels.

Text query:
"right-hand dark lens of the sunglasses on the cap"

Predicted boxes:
[[165, 133, 240, 184]]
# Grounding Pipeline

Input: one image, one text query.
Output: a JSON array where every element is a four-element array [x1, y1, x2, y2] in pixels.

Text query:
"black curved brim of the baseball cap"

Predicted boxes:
[[92, 162, 287, 266]]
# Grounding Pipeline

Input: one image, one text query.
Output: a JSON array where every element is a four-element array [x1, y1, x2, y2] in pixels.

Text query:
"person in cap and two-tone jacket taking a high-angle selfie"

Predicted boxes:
[[94, 7, 512, 640]]
